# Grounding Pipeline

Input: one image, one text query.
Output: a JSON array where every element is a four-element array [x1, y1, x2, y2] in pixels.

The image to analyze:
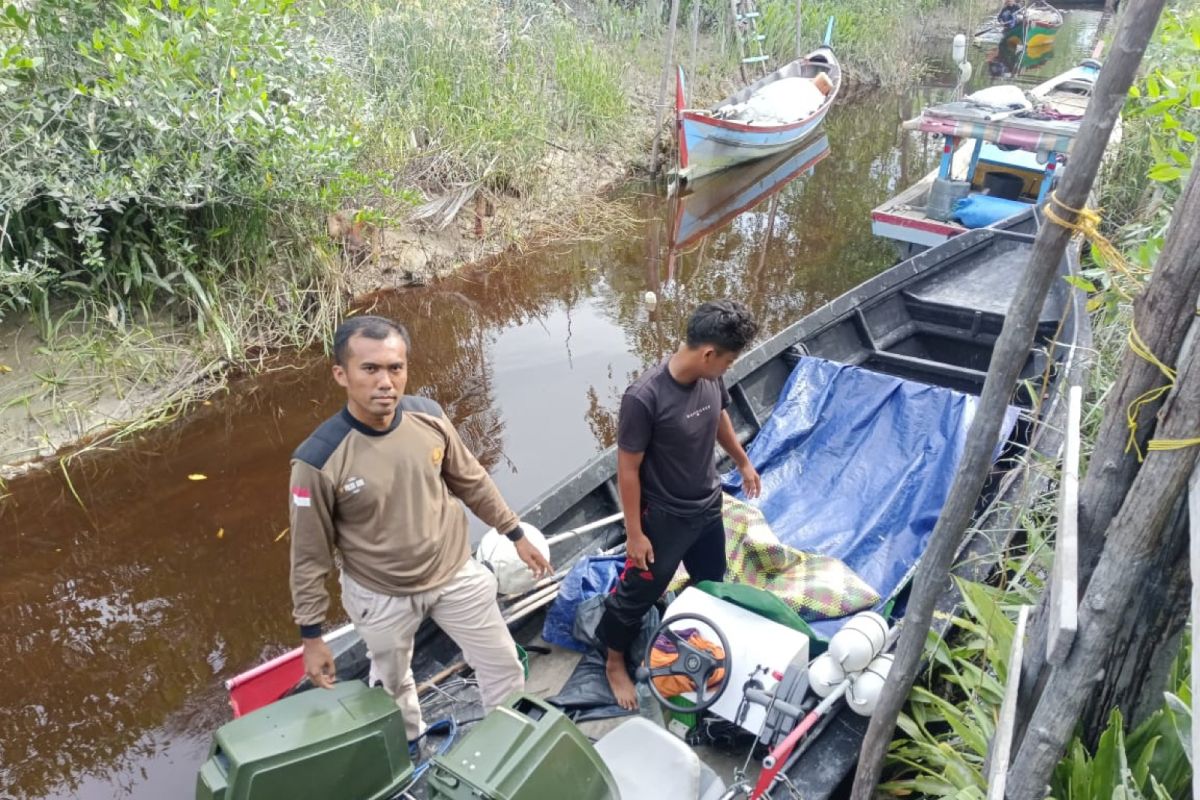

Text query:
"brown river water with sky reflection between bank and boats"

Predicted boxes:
[[0, 12, 1099, 800]]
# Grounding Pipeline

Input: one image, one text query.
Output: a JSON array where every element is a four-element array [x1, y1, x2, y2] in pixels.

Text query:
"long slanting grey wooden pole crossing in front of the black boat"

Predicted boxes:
[[851, 0, 1165, 800]]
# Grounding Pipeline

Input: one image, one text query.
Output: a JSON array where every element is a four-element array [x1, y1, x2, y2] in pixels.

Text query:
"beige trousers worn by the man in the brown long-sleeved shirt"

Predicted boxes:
[[342, 559, 524, 741]]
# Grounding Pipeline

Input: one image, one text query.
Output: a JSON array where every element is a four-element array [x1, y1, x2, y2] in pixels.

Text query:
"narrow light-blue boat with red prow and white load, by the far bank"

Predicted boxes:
[[676, 47, 841, 181]]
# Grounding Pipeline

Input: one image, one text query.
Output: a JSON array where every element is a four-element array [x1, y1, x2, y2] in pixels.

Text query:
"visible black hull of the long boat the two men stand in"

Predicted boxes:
[[225, 210, 1090, 800]]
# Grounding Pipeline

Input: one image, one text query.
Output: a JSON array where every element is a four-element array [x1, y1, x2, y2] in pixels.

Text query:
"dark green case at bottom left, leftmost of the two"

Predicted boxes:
[[196, 680, 413, 800]]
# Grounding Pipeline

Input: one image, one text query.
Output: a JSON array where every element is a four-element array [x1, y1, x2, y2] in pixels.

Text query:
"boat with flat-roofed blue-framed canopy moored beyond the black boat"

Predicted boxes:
[[871, 59, 1120, 258]]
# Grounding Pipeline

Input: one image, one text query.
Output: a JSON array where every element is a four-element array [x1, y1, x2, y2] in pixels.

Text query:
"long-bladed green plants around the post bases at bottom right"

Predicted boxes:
[[880, 573, 1192, 800]]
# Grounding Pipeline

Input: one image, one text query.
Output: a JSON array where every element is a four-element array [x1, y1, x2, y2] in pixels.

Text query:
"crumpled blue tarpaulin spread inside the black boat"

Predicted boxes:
[[725, 357, 1016, 633]]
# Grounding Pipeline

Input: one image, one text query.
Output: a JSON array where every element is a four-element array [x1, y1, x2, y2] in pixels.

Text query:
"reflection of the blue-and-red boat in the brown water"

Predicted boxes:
[[671, 134, 829, 249]]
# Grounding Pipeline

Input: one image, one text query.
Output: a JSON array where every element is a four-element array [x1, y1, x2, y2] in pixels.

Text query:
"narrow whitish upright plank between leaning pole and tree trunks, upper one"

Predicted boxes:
[[1046, 386, 1084, 664]]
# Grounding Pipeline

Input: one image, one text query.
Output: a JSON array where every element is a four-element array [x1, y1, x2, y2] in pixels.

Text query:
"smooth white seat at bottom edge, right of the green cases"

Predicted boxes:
[[595, 717, 725, 800]]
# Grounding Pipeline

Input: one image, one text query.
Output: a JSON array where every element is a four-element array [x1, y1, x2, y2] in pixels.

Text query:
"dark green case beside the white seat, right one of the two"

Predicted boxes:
[[428, 694, 620, 800]]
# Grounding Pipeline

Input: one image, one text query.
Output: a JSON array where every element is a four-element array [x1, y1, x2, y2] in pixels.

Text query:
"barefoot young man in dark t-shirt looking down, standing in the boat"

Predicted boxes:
[[598, 300, 760, 709]]
